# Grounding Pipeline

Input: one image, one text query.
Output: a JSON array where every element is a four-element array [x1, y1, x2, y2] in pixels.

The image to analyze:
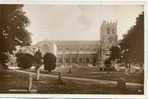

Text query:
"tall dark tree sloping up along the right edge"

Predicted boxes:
[[120, 13, 144, 65]]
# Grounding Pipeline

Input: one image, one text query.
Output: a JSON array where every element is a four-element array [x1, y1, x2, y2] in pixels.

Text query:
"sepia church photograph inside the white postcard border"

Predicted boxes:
[[0, 0, 145, 95]]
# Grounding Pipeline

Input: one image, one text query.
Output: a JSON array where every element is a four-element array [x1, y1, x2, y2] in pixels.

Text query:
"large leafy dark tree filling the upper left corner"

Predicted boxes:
[[0, 4, 31, 68]]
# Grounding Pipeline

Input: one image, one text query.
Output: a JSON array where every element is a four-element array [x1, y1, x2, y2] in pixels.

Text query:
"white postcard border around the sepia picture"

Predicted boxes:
[[0, 0, 148, 99]]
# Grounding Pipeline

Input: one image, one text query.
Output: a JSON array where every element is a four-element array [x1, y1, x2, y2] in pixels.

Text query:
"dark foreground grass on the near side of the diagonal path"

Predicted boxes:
[[0, 71, 143, 94]]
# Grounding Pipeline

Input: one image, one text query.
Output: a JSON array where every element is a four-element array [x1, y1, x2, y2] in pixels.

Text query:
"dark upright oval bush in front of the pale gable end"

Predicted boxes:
[[43, 53, 56, 72]]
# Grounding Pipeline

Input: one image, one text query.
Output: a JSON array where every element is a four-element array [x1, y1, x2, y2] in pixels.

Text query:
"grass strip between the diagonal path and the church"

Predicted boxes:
[[34, 66, 144, 84]]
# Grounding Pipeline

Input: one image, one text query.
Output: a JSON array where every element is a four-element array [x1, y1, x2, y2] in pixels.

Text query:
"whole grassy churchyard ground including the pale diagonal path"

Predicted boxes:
[[0, 63, 144, 94]]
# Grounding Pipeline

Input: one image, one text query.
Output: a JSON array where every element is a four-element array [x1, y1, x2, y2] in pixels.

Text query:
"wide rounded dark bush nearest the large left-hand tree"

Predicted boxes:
[[16, 53, 34, 69]]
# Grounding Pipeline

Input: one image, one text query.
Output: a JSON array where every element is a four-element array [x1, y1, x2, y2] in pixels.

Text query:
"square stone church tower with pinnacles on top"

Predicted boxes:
[[100, 21, 118, 69]]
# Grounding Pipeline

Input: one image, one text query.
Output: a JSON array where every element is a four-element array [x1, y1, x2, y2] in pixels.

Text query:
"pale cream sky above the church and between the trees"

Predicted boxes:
[[23, 5, 144, 43]]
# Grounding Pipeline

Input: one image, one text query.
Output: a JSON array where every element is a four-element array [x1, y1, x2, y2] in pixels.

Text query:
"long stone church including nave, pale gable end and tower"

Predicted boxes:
[[20, 21, 117, 67]]
